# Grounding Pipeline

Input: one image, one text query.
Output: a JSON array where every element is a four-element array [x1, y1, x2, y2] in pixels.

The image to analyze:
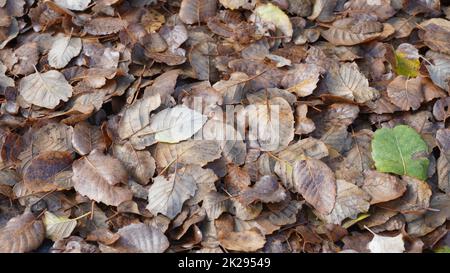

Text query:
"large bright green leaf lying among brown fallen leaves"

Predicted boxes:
[[372, 125, 429, 180]]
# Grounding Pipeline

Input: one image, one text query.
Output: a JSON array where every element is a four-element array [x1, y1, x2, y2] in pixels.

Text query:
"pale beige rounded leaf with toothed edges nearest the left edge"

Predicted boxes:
[[19, 70, 72, 109]]
